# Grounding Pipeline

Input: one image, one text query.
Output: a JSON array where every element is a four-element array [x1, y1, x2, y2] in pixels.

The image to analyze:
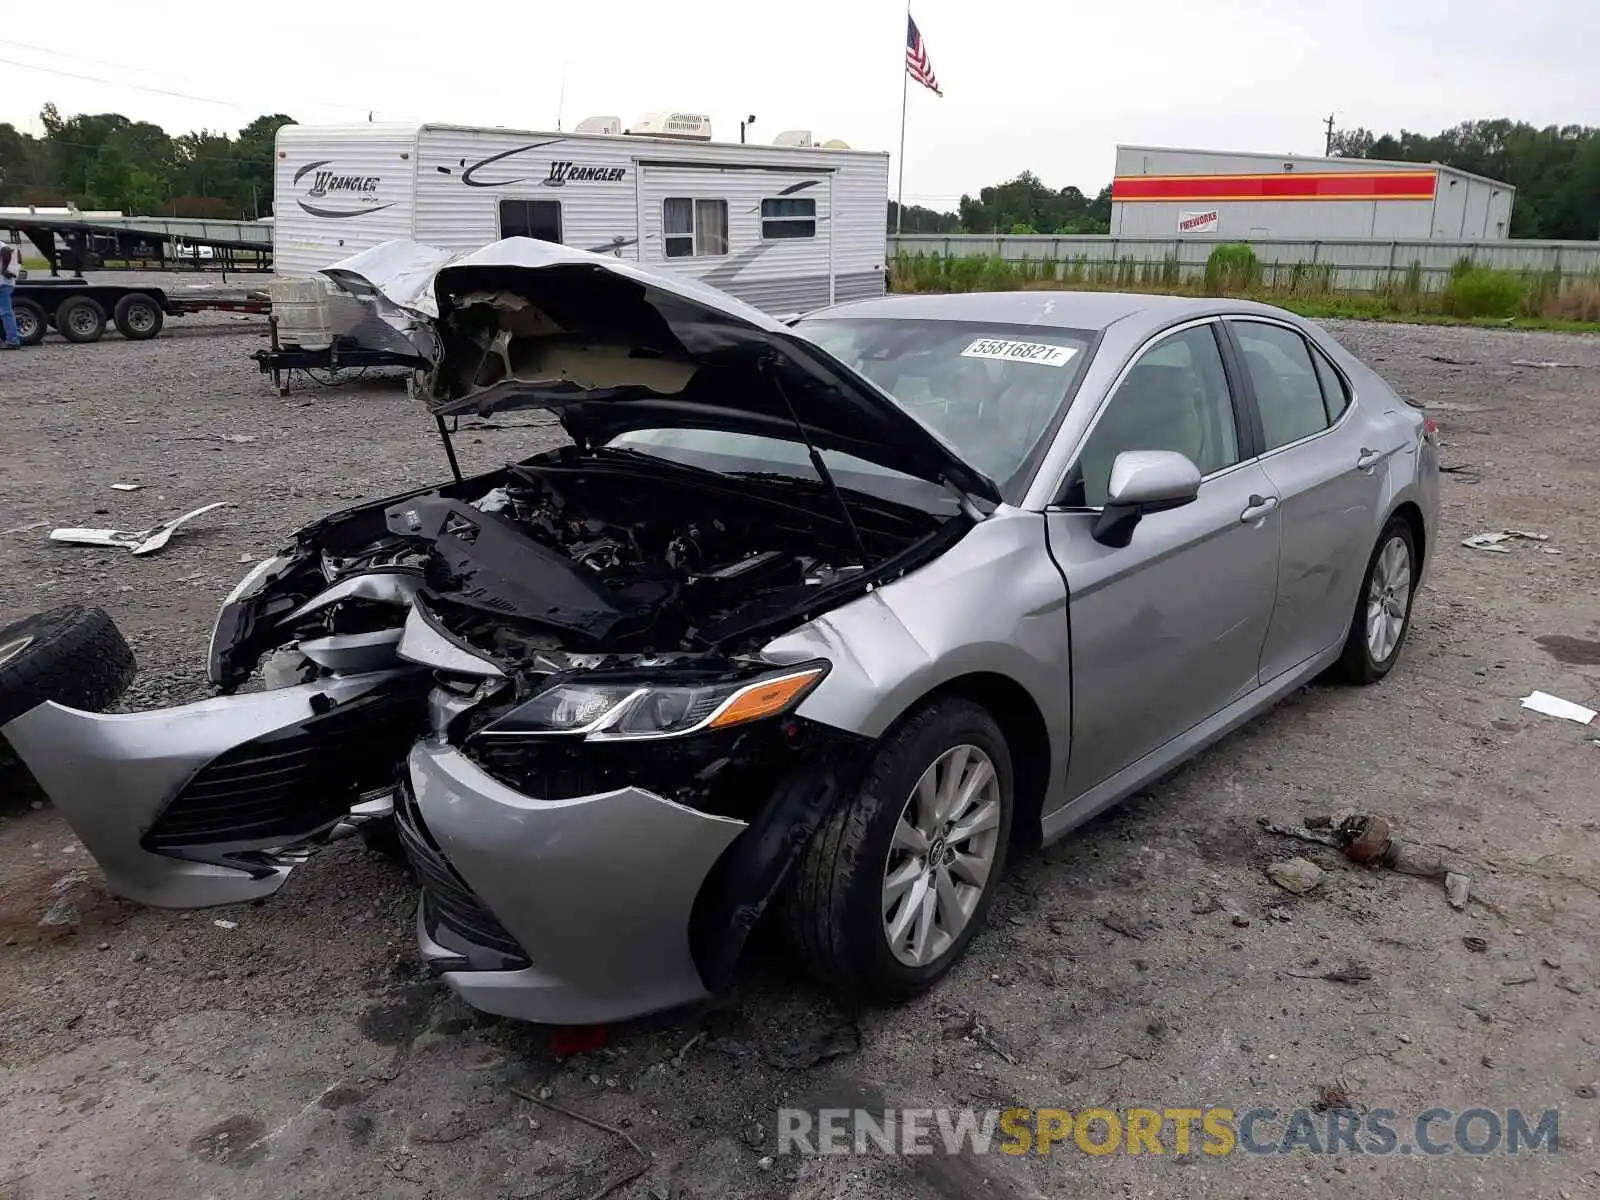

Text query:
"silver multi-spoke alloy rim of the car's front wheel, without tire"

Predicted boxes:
[[883, 746, 1002, 966]]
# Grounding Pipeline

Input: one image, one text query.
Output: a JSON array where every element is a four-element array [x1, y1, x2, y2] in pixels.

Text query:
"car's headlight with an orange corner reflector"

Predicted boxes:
[[477, 662, 827, 741]]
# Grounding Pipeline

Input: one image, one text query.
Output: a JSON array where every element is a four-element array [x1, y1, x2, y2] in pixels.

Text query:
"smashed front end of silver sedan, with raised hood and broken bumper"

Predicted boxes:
[[3, 238, 998, 1021]]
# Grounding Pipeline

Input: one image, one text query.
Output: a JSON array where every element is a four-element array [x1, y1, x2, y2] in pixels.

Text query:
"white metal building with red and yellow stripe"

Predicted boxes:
[[1110, 146, 1517, 242]]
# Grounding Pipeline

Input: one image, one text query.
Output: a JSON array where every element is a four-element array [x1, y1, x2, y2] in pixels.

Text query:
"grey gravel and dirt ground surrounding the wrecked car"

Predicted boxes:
[[0, 307, 1600, 1200]]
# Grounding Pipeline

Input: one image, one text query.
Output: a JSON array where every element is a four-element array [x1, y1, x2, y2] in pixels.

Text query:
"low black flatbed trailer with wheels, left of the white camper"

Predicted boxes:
[[11, 278, 272, 346]]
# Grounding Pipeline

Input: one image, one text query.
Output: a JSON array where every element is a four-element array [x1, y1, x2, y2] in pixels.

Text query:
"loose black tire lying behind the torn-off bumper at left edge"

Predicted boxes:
[[0, 605, 134, 725]]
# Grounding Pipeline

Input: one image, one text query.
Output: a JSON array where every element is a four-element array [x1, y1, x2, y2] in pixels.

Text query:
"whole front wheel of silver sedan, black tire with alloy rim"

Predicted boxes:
[[784, 696, 1013, 1000]]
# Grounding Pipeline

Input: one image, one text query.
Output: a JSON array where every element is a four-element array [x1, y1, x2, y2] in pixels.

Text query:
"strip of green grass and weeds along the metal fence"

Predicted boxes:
[[890, 246, 1600, 333]]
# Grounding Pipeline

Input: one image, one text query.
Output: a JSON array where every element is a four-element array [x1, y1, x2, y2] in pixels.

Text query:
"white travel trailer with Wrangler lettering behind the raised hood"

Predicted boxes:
[[274, 112, 888, 346]]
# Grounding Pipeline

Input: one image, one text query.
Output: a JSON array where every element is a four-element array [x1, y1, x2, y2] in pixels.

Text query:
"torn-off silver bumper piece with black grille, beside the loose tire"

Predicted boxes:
[[0, 670, 421, 909]]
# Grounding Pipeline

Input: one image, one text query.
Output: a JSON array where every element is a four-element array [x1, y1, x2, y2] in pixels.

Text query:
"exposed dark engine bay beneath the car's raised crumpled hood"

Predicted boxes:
[[213, 446, 963, 690]]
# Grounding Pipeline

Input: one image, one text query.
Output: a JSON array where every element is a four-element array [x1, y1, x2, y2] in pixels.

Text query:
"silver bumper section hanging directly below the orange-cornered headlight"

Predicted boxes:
[[397, 741, 747, 1024]]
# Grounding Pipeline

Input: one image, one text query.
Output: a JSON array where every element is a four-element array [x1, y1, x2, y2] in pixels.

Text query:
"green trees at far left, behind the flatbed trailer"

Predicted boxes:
[[0, 104, 294, 221]]
